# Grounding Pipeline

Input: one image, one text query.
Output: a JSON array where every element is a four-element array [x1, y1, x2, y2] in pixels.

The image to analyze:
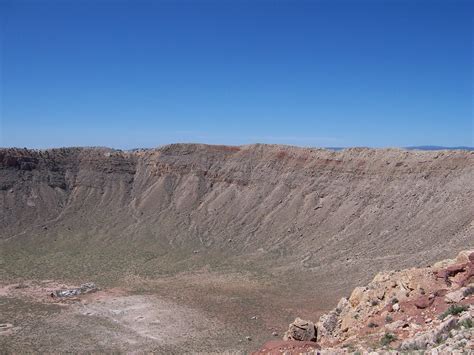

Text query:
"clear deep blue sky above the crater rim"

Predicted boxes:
[[0, 0, 474, 149]]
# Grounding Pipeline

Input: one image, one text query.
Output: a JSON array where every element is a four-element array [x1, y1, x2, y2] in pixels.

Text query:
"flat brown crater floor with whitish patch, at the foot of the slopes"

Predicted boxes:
[[0, 271, 324, 353]]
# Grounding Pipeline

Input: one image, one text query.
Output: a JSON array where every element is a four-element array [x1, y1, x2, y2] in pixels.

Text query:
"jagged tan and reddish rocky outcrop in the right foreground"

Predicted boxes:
[[263, 251, 474, 354]]
